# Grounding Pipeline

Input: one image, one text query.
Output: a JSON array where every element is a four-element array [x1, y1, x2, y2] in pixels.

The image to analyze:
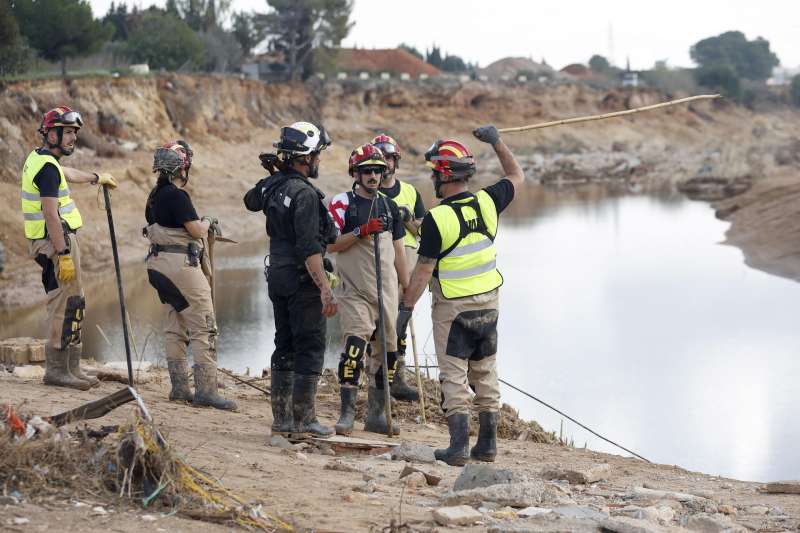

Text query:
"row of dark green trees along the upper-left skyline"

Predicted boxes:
[[0, 0, 353, 80]]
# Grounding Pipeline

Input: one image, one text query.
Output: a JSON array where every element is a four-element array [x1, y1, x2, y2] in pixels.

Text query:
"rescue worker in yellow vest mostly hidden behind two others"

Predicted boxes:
[[372, 133, 425, 402]]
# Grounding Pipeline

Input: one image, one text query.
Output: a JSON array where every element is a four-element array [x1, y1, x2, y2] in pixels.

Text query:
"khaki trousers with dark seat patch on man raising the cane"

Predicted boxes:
[[431, 278, 500, 416]]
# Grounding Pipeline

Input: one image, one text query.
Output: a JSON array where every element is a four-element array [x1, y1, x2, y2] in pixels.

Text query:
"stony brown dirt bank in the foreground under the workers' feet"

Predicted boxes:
[[0, 371, 800, 532]]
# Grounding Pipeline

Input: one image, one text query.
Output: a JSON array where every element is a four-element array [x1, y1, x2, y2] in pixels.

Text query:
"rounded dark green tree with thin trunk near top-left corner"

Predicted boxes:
[[13, 0, 114, 76]]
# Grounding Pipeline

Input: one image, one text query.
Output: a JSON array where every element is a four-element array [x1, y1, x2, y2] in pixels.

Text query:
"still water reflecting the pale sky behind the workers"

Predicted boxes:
[[0, 187, 800, 481]]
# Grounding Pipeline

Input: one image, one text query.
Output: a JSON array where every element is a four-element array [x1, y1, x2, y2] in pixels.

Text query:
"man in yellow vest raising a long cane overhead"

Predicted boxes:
[[397, 126, 525, 466]]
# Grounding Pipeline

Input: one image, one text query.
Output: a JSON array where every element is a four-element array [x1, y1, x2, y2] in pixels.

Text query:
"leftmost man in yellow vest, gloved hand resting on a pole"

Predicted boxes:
[[21, 106, 117, 390]]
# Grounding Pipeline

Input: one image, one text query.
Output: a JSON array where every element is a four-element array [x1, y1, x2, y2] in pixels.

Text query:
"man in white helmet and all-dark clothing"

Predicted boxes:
[[244, 122, 337, 437]]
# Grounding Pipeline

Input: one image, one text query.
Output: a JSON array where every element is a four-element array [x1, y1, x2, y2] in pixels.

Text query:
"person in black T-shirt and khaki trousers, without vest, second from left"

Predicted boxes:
[[144, 140, 236, 410]]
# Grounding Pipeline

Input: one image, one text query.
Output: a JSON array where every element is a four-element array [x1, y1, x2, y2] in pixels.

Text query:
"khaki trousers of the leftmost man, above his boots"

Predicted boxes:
[[28, 233, 86, 350]]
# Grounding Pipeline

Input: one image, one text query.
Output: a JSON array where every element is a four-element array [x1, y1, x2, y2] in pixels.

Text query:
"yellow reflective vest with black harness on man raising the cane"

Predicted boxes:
[[430, 191, 503, 299]]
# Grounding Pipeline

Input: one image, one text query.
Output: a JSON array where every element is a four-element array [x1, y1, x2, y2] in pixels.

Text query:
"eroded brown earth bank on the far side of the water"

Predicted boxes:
[[0, 75, 800, 309]]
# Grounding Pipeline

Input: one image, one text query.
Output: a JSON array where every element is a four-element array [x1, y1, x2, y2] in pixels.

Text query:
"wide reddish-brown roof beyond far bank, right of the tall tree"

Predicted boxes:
[[336, 48, 442, 78]]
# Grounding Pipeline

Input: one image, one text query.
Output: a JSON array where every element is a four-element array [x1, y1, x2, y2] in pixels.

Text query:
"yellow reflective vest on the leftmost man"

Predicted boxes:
[[21, 150, 83, 239]]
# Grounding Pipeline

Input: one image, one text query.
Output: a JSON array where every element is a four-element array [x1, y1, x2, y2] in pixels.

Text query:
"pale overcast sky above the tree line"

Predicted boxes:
[[90, 0, 800, 69]]
